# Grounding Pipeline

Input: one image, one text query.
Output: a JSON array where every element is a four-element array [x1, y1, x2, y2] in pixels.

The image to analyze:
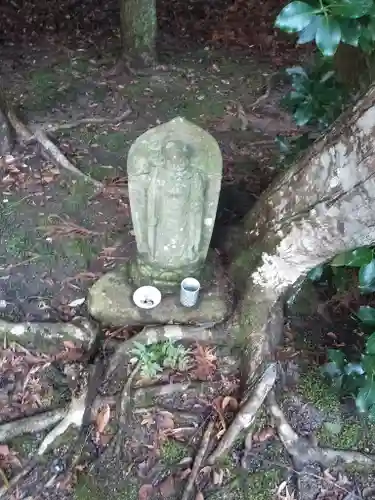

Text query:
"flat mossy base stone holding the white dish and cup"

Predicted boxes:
[[88, 271, 230, 327]]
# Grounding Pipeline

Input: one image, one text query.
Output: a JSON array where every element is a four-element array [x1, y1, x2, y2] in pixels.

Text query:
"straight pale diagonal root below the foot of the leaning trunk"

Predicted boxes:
[[208, 363, 277, 465]]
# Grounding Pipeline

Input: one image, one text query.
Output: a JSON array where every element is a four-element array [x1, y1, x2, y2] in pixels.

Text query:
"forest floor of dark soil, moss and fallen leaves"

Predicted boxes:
[[0, 2, 375, 500]]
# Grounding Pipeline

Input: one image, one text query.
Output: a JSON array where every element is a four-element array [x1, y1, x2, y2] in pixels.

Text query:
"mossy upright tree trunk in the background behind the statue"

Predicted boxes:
[[120, 0, 157, 65]]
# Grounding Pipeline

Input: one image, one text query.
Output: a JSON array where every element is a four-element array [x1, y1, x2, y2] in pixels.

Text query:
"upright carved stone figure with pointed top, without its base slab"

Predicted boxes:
[[128, 118, 222, 290]]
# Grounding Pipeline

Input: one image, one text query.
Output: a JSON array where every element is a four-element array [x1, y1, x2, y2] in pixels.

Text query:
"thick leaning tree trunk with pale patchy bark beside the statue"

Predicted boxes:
[[231, 85, 375, 374]]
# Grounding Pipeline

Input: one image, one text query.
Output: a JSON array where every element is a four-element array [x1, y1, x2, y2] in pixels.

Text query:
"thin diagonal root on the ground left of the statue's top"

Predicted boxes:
[[8, 111, 103, 189]]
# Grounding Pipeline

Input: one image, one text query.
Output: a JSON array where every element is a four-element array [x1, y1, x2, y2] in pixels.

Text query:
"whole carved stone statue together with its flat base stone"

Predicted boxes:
[[88, 118, 230, 326]]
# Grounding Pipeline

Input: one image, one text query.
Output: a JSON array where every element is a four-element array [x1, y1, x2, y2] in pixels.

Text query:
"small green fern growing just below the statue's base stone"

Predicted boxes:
[[132, 340, 190, 378]]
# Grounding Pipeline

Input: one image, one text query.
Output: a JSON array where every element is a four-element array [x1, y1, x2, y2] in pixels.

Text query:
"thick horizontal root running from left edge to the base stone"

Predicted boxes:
[[0, 318, 96, 346]]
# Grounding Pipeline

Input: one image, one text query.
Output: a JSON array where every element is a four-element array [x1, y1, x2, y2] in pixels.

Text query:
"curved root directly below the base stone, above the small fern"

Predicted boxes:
[[107, 325, 226, 377]]
